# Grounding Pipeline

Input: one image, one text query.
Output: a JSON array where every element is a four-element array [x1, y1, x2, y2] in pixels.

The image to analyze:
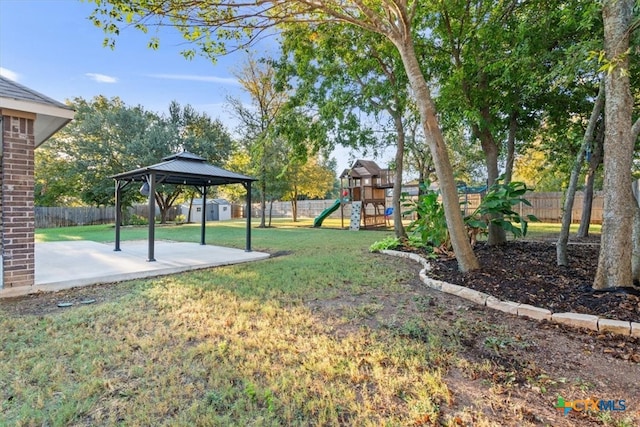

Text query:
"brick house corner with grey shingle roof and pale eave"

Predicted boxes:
[[0, 76, 74, 289]]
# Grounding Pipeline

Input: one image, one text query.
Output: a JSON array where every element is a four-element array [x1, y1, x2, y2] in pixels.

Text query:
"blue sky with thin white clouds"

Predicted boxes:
[[0, 0, 390, 173]]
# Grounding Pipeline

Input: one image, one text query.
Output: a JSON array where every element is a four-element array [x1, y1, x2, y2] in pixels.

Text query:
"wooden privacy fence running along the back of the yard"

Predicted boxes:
[[35, 192, 603, 228]]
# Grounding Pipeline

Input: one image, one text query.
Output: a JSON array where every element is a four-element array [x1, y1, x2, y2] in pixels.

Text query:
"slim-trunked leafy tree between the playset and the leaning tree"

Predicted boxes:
[[279, 23, 412, 238]]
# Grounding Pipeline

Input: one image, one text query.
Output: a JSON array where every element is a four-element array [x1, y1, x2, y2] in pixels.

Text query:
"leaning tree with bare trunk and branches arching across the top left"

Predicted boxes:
[[91, 0, 479, 271]]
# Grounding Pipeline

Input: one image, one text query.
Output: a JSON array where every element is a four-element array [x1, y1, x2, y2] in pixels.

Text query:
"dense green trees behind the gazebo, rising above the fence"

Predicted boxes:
[[35, 96, 233, 213]]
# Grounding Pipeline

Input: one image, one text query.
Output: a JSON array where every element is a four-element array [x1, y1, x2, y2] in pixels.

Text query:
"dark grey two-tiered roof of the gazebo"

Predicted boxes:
[[112, 151, 256, 186]]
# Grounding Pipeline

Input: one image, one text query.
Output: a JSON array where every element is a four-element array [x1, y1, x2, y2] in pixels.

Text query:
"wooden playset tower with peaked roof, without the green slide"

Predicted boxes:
[[340, 160, 393, 228]]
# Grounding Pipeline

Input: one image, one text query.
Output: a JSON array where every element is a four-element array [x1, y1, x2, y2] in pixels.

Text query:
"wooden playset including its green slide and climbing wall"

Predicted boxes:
[[313, 160, 393, 230]]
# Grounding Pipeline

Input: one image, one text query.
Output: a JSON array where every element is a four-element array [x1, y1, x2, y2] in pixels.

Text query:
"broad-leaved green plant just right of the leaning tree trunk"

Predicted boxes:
[[464, 176, 538, 238]]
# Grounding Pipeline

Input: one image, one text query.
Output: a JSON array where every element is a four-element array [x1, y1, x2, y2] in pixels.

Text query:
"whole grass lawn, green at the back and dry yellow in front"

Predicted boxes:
[[0, 220, 616, 426]]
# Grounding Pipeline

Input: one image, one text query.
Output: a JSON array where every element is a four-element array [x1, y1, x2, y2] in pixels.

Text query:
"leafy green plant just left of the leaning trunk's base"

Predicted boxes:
[[401, 183, 451, 249]]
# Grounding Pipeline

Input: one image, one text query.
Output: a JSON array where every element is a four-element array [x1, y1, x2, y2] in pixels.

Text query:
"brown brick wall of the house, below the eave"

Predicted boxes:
[[0, 113, 35, 288]]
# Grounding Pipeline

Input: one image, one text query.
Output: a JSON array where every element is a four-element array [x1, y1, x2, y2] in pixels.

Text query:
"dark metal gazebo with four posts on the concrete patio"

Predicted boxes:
[[112, 151, 256, 261]]
